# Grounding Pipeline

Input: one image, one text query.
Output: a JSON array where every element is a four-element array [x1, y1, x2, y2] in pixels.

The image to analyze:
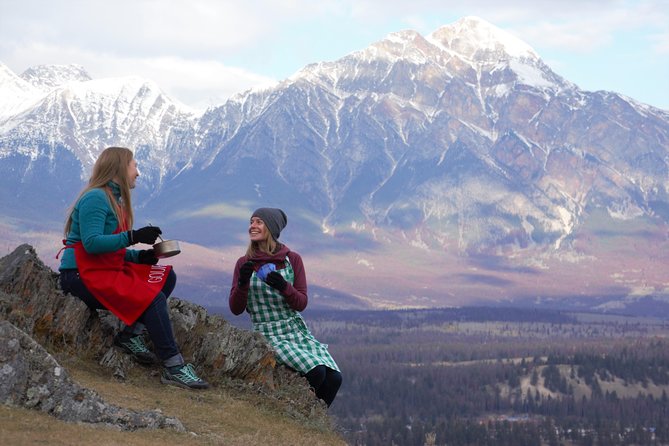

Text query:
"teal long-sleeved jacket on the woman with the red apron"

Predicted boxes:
[[59, 182, 139, 270]]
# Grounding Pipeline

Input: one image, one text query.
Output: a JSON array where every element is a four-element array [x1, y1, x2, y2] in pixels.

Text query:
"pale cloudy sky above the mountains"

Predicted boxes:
[[0, 0, 669, 110]]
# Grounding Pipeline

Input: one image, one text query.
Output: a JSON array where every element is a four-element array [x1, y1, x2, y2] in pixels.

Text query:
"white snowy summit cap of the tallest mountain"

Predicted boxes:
[[427, 16, 539, 60]]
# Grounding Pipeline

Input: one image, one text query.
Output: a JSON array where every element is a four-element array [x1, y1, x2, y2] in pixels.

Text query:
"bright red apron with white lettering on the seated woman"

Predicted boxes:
[[67, 227, 172, 325]]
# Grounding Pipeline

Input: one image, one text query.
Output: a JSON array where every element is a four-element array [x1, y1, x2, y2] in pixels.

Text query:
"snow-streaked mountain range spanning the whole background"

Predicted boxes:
[[0, 17, 669, 312]]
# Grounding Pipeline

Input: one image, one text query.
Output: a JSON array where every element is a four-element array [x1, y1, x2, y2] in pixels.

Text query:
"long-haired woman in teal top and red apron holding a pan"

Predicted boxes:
[[59, 147, 209, 389]]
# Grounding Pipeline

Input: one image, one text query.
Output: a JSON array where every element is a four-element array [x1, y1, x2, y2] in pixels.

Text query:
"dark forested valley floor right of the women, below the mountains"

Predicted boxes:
[[304, 307, 669, 446]]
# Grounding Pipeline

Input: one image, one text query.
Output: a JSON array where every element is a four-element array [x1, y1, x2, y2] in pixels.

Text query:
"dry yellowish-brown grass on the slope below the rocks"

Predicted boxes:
[[0, 358, 345, 446]]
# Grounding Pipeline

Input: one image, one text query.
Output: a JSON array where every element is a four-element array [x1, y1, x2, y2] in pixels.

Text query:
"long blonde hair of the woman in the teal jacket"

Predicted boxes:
[[65, 147, 134, 237]]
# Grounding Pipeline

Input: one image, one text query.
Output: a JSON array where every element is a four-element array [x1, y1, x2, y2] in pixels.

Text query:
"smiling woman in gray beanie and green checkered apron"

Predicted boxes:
[[229, 208, 342, 406]]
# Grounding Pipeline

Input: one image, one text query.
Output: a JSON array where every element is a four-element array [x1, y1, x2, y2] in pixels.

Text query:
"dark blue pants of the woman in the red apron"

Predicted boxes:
[[60, 270, 180, 361]]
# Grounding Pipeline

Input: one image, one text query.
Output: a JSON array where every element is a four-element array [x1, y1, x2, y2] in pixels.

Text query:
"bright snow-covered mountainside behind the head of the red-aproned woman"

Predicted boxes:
[[0, 69, 193, 172]]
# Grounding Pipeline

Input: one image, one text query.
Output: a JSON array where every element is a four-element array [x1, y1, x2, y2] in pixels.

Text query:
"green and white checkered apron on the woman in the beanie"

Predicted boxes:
[[246, 257, 339, 373]]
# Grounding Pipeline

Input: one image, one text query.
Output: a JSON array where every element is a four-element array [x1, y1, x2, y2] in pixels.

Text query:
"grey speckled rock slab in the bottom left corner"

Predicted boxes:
[[0, 321, 185, 432]]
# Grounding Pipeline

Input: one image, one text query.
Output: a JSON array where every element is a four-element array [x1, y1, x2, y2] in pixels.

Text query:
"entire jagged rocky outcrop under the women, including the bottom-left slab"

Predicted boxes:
[[0, 245, 329, 429]]
